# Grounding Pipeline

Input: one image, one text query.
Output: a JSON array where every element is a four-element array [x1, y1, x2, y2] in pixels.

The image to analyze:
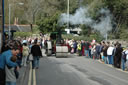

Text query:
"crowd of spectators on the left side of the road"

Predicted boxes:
[[0, 38, 42, 85]]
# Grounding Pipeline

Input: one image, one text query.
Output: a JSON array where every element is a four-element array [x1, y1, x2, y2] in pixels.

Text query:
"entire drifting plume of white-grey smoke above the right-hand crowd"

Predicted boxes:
[[59, 7, 112, 35]]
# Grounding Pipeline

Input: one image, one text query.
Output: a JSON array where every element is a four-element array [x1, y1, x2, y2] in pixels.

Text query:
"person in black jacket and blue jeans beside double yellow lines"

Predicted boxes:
[[31, 41, 42, 69]]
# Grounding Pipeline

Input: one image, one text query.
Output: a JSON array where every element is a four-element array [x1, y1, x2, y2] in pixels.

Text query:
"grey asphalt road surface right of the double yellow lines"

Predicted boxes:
[[35, 55, 128, 85]]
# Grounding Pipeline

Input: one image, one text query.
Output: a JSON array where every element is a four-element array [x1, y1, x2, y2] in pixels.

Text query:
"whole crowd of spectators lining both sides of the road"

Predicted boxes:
[[0, 37, 128, 85]]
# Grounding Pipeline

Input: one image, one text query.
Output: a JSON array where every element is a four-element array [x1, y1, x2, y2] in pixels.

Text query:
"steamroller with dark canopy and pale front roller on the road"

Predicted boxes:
[[47, 32, 68, 58]]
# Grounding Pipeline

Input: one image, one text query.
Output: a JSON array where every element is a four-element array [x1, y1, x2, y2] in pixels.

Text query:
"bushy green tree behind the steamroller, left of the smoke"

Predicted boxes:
[[37, 12, 64, 33]]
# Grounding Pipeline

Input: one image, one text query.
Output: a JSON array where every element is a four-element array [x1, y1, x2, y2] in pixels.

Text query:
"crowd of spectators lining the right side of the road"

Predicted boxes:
[[65, 40, 128, 70]]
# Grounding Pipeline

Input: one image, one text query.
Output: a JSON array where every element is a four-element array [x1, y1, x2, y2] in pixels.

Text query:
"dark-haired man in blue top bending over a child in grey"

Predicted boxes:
[[0, 40, 19, 85]]
